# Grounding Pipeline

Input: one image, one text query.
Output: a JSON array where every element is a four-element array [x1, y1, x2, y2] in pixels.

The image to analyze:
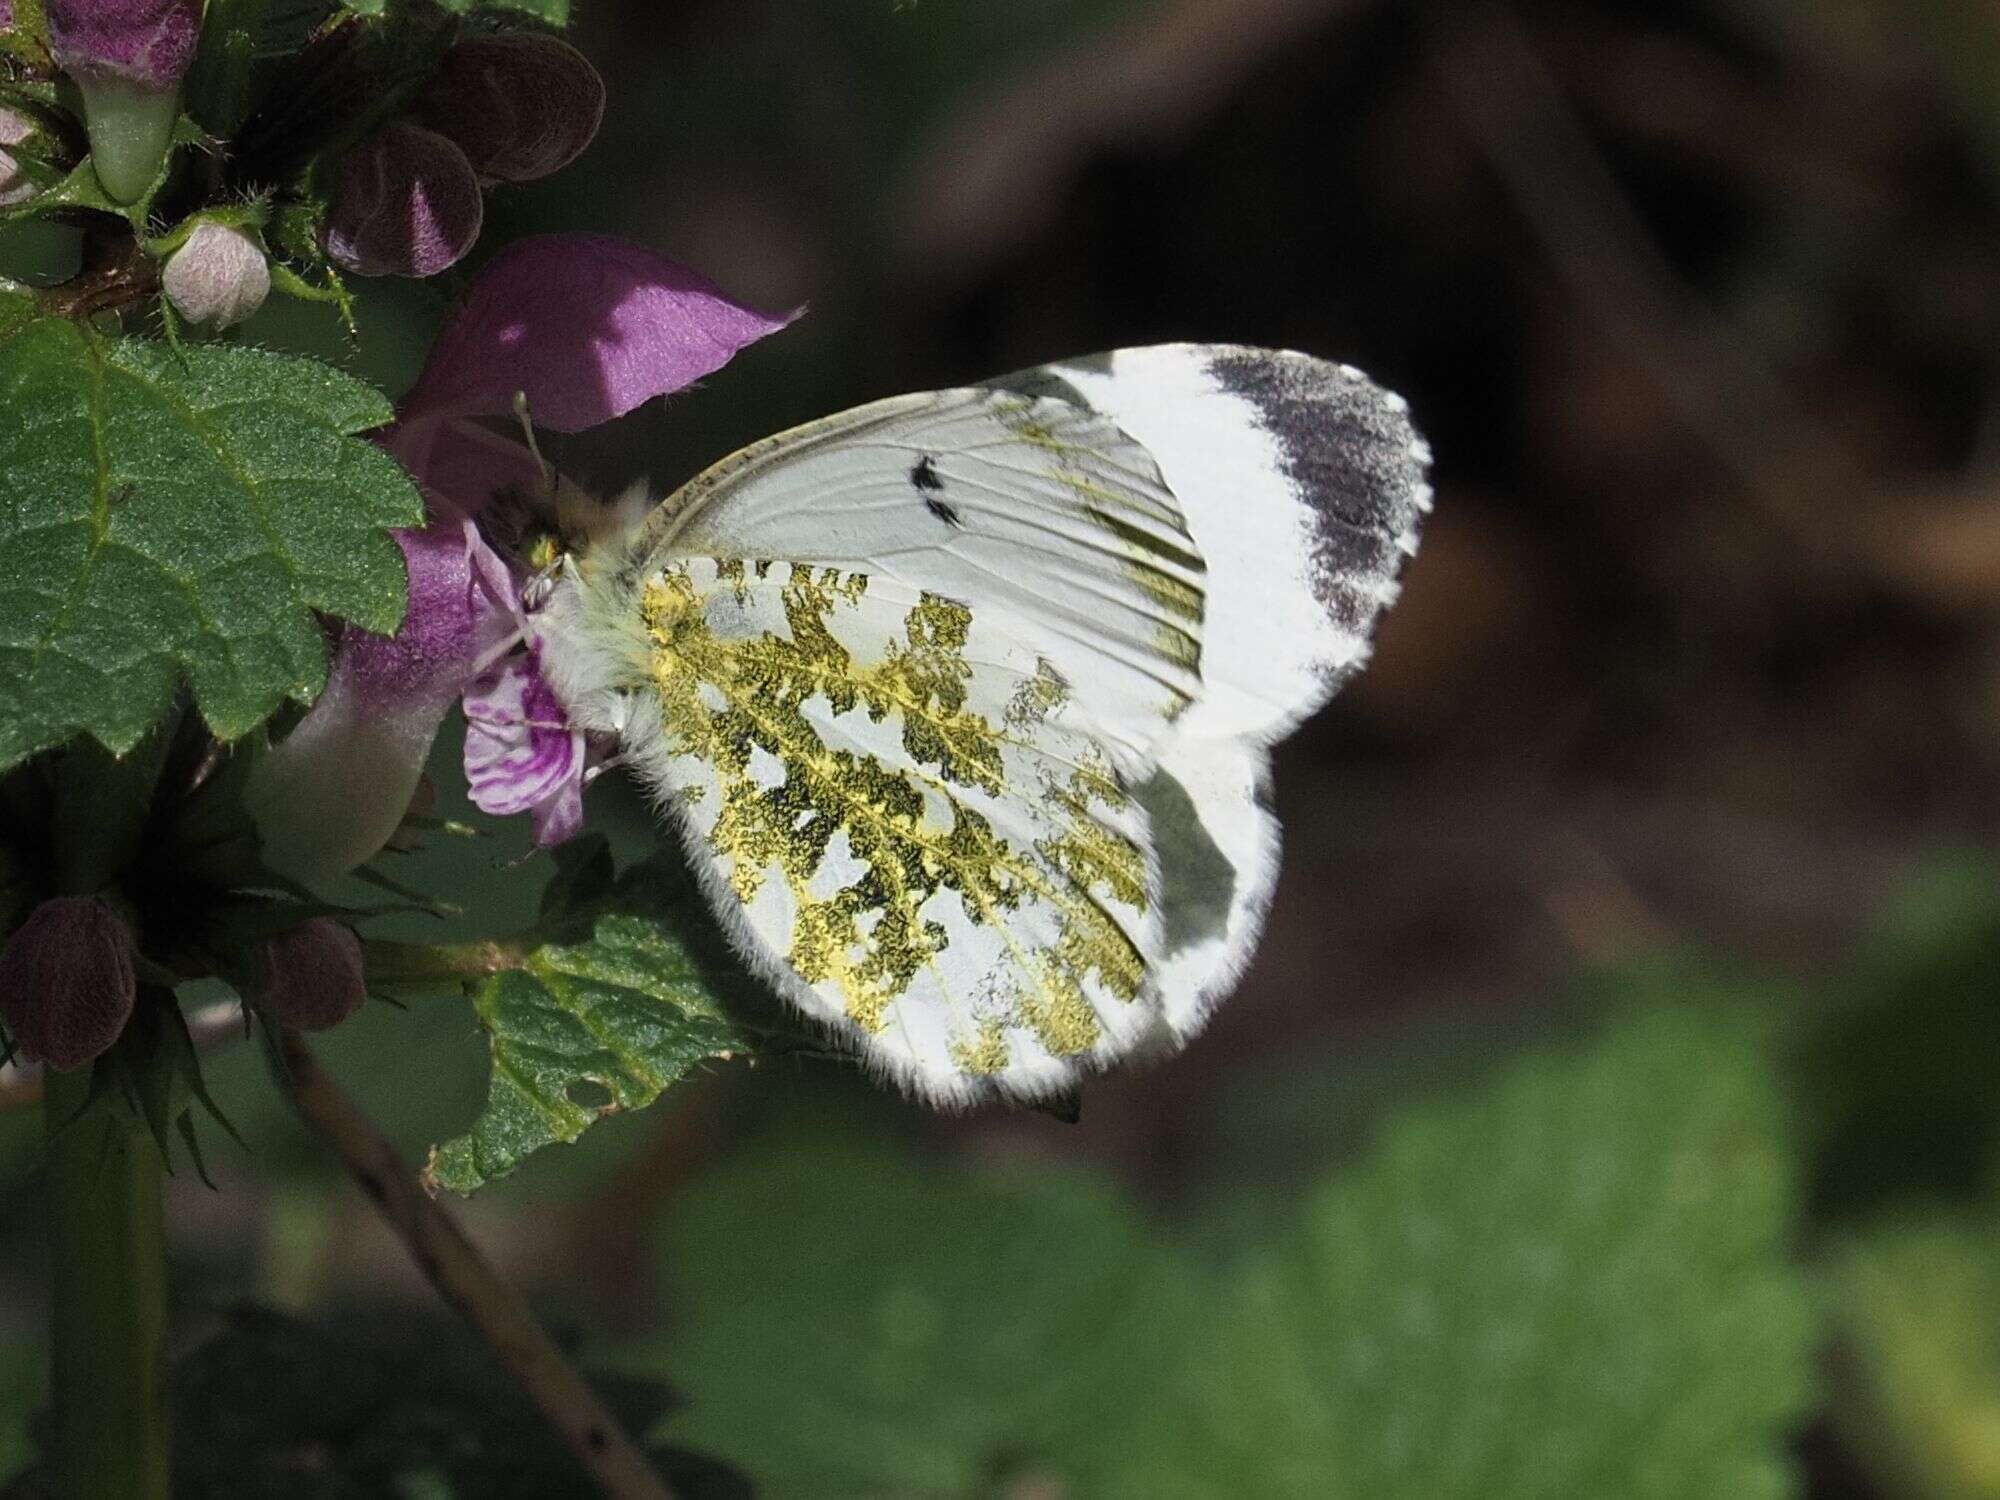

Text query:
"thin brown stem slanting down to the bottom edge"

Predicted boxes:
[[280, 1032, 672, 1500]]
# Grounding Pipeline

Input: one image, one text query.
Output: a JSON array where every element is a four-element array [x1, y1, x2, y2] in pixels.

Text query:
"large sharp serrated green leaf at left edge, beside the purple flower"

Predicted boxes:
[[0, 318, 422, 768]]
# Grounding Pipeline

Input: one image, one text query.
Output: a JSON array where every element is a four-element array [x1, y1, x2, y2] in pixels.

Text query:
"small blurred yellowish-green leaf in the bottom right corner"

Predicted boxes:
[[1830, 1212, 2000, 1500]]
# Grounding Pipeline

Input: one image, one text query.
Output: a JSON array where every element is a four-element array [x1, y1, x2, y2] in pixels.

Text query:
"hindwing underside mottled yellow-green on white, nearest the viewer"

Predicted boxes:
[[608, 558, 1160, 1098]]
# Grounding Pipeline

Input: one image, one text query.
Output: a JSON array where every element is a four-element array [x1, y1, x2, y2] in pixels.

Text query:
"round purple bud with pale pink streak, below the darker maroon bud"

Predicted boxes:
[[326, 122, 486, 276]]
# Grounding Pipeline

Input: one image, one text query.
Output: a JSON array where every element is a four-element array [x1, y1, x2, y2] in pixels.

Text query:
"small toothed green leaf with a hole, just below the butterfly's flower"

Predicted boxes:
[[424, 892, 754, 1192]]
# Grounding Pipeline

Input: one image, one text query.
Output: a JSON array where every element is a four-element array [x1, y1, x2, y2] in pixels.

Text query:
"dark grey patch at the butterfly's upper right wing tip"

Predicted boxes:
[[1208, 346, 1432, 636]]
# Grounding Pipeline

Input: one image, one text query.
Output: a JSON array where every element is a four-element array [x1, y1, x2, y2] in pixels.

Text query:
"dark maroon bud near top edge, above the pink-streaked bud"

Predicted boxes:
[[416, 34, 604, 182]]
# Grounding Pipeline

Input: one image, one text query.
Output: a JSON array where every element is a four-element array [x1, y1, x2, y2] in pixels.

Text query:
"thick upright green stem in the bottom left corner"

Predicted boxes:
[[42, 1068, 172, 1500]]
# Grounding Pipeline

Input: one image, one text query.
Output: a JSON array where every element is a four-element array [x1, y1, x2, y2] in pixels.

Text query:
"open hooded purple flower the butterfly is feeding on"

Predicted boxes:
[[252, 234, 790, 882]]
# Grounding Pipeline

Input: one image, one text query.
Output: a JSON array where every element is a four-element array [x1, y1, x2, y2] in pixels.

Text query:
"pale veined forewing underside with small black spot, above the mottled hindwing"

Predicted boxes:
[[642, 388, 1204, 770]]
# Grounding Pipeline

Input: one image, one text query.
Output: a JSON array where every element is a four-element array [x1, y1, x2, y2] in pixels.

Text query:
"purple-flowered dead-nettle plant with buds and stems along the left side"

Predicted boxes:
[[0, 14, 784, 1500]]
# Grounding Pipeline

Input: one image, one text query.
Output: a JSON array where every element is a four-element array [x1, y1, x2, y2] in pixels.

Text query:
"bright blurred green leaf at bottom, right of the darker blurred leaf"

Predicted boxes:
[[1104, 1012, 1814, 1500]]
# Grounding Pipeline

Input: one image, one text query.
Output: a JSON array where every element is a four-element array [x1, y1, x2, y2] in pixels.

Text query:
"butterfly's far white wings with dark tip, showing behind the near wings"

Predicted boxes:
[[1040, 344, 1432, 1046]]
